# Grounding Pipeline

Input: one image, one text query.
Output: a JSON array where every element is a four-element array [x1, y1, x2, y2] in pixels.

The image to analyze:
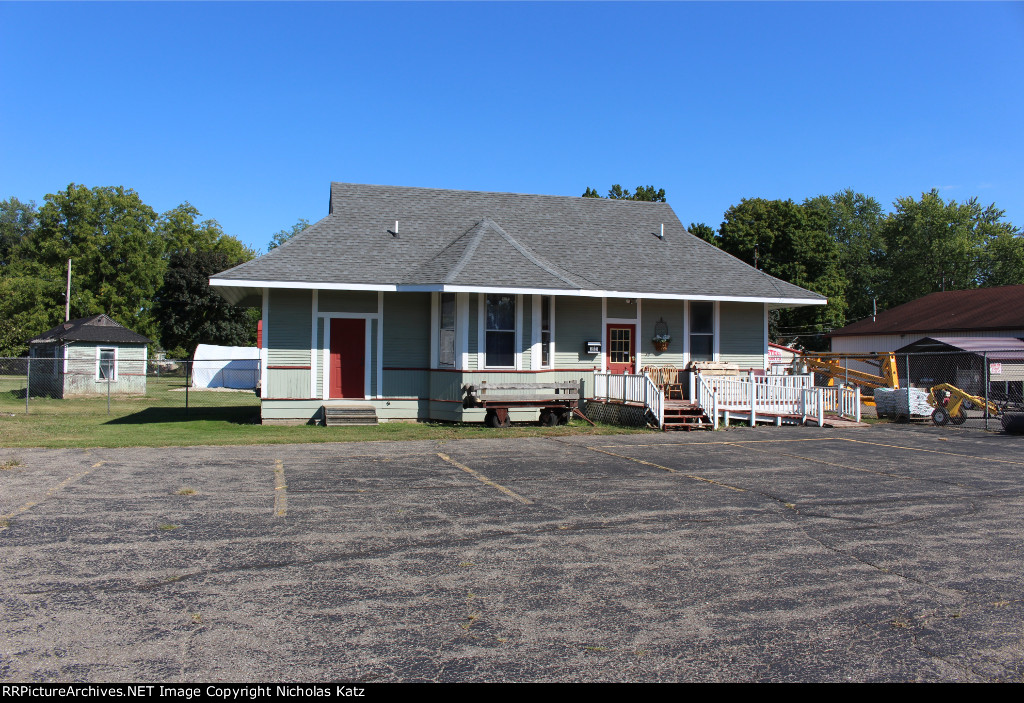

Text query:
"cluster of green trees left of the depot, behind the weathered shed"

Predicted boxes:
[[0, 183, 259, 358]]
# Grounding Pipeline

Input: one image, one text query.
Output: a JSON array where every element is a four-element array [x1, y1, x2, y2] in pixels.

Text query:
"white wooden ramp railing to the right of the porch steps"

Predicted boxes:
[[690, 372, 860, 428]]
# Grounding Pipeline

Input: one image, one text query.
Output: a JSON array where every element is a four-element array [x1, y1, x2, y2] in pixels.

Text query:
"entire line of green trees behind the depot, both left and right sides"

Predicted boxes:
[[0, 183, 1024, 357]]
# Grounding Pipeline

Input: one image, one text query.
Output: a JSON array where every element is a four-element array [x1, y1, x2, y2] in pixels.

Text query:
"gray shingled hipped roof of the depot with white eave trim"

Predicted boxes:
[[212, 183, 824, 304]]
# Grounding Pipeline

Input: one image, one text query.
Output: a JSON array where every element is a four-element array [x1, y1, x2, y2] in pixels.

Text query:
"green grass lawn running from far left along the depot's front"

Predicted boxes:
[[0, 377, 649, 447]]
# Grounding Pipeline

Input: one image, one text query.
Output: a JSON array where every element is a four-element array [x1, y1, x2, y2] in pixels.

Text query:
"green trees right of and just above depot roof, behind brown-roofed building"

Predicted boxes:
[[584, 185, 1024, 349]]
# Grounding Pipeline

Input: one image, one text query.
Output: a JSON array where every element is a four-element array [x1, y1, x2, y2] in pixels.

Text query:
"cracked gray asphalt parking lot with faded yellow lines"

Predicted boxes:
[[0, 426, 1024, 682]]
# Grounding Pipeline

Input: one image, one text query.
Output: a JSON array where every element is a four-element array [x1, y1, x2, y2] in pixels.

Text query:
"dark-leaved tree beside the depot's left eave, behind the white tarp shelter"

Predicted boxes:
[[155, 249, 259, 358]]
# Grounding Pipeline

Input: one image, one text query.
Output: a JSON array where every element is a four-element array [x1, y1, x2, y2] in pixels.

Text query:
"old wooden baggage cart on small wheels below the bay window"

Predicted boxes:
[[462, 381, 593, 427]]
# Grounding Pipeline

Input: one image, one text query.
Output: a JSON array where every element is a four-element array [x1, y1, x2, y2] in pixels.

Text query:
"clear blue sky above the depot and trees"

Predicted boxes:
[[0, 2, 1024, 250]]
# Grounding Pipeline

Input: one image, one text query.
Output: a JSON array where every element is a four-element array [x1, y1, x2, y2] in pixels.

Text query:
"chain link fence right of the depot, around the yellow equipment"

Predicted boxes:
[[802, 345, 1024, 430]]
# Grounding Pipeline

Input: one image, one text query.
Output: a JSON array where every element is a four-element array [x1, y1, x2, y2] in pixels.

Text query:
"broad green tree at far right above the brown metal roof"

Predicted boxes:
[[882, 189, 1017, 307]]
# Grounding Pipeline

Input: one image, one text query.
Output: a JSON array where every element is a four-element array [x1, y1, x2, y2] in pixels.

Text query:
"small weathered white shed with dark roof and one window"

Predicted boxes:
[[29, 314, 150, 398]]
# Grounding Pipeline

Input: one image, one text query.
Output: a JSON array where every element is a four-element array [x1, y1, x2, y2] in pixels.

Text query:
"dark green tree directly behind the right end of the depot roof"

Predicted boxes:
[[719, 199, 847, 349]]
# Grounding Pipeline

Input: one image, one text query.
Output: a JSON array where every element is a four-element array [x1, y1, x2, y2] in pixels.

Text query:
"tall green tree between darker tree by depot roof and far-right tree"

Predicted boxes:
[[804, 188, 886, 322]]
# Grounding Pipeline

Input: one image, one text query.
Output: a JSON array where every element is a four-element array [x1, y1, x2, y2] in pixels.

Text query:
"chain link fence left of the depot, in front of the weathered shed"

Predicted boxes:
[[0, 349, 260, 423]]
